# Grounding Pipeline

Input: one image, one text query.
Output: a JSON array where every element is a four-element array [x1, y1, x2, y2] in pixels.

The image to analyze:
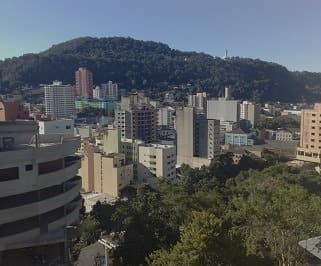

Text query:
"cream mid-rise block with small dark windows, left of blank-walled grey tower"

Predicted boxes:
[[138, 144, 176, 182]]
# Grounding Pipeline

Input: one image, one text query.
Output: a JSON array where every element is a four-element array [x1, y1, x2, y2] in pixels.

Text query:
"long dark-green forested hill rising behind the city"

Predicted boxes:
[[0, 37, 321, 101]]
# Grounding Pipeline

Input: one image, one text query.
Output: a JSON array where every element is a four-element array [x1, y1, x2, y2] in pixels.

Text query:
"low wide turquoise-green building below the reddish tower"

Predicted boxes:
[[75, 98, 115, 116]]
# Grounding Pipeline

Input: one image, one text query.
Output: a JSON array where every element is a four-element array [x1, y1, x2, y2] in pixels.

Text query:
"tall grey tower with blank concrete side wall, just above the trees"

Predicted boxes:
[[175, 107, 220, 167]]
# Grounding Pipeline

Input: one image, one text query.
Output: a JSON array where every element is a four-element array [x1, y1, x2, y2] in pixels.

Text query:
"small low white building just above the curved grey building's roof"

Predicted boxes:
[[38, 119, 74, 136]]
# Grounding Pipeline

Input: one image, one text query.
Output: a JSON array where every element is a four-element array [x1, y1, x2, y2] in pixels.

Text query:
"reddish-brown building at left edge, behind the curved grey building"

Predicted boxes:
[[0, 100, 29, 121]]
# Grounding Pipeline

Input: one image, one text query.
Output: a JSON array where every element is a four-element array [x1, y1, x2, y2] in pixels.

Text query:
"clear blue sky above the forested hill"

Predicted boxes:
[[0, 0, 321, 72]]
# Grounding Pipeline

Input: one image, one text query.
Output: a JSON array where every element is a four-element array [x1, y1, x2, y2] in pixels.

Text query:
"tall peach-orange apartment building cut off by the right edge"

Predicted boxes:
[[296, 103, 321, 163]]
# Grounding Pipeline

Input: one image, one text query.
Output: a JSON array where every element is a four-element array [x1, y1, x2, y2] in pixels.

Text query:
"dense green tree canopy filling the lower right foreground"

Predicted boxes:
[[75, 155, 321, 266]]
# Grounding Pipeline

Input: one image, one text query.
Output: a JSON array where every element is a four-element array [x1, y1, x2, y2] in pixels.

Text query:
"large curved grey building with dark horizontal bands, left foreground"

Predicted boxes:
[[0, 121, 82, 258]]
